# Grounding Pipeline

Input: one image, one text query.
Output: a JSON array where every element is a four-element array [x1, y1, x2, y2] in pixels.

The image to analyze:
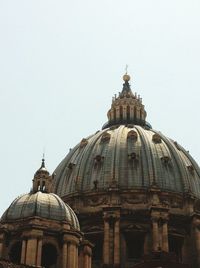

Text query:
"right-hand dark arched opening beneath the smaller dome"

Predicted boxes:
[[41, 243, 58, 268]]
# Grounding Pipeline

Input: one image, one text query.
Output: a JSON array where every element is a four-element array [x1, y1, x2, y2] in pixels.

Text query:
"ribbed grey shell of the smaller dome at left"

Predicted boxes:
[[1, 192, 80, 230]]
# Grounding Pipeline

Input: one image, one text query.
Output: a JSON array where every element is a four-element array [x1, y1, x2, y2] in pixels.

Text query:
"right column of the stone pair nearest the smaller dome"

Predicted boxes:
[[114, 217, 120, 266]]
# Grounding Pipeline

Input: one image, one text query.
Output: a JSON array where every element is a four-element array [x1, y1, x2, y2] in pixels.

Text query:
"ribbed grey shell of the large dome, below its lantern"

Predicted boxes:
[[53, 125, 200, 198]]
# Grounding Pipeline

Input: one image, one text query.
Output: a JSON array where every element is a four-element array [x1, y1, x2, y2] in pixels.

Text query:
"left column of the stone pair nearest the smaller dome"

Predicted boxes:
[[103, 217, 110, 264]]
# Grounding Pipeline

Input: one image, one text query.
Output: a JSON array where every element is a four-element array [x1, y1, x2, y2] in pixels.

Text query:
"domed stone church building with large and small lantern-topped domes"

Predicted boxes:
[[0, 73, 200, 268]]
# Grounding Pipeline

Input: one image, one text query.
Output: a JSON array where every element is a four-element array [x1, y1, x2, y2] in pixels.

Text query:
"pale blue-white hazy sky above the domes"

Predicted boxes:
[[0, 0, 200, 214]]
